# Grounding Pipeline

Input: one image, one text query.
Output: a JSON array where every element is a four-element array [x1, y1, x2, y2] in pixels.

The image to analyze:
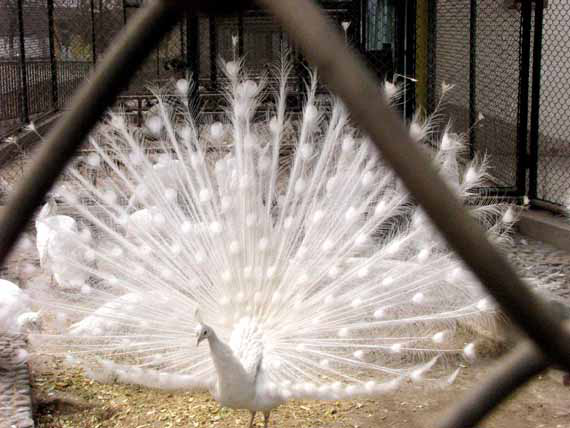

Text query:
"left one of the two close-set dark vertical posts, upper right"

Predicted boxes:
[[516, 0, 532, 195]]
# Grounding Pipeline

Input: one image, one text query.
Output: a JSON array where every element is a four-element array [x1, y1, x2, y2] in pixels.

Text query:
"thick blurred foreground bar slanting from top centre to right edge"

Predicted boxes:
[[257, 0, 570, 369]]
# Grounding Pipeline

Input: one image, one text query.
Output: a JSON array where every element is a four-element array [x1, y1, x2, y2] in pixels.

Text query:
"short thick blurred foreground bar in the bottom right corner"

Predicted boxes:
[[437, 341, 549, 428]]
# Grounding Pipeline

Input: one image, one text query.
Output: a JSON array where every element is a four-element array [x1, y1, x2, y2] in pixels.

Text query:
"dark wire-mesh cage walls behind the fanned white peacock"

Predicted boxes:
[[0, 0, 570, 207]]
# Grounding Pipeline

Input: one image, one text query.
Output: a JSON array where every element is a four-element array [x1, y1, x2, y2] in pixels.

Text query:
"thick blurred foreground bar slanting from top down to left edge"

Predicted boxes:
[[0, 0, 184, 266]]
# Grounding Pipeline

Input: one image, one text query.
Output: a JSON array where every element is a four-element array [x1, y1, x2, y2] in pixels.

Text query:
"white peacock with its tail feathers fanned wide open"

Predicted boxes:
[[27, 57, 514, 426]]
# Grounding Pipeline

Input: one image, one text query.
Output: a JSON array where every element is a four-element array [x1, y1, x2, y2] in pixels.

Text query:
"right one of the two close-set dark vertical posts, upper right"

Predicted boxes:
[[528, 0, 544, 199]]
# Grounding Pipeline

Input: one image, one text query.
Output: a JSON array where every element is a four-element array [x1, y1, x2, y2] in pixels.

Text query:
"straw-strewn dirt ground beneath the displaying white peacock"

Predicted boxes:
[[31, 352, 570, 428]]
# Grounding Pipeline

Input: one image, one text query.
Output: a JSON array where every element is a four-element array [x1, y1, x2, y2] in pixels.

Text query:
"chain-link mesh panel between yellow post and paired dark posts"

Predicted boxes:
[[427, 0, 521, 192]]
